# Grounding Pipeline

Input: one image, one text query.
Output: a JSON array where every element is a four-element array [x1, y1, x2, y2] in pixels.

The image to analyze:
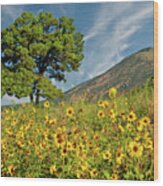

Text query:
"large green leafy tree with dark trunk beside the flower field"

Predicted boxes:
[[1, 12, 84, 104]]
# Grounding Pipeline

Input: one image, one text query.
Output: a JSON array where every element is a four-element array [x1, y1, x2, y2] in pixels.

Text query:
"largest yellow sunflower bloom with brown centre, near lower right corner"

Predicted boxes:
[[129, 141, 143, 158]]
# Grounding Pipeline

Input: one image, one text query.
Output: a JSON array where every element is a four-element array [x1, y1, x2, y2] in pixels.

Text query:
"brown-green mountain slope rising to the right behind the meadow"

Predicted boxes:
[[66, 48, 154, 100]]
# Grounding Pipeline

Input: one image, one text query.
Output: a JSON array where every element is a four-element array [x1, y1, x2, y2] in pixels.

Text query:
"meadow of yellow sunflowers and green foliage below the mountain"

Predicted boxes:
[[1, 81, 154, 180]]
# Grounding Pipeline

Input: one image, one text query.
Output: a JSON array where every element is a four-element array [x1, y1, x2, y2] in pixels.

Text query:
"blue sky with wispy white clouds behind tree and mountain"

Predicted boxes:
[[1, 1, 154, 105]]
